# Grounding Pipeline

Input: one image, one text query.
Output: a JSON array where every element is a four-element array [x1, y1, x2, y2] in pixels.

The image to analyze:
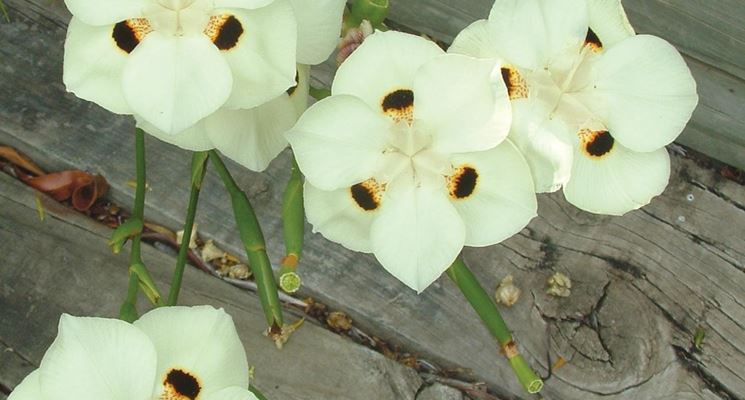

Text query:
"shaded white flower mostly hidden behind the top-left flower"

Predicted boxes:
[[129, 0, 345, 171]]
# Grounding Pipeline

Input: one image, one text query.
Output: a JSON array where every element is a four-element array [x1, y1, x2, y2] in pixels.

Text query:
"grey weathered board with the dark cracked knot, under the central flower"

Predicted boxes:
[[0, 0, 745, 399]]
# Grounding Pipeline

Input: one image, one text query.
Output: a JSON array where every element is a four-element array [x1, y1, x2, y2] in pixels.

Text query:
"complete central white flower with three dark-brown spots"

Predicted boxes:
[[287, 32, 536, 292]]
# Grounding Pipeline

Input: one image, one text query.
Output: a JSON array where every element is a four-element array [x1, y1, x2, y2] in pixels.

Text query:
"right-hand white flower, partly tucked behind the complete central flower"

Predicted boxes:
[[450, 0, 698, 215]]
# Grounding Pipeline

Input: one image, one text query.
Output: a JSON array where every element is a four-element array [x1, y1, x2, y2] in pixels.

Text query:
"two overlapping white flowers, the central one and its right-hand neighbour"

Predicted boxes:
[[287, 0, 698, 291]]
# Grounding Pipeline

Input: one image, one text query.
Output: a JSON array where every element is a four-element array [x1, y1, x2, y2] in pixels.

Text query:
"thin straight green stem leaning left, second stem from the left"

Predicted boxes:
[[167, 152, 207, 306]]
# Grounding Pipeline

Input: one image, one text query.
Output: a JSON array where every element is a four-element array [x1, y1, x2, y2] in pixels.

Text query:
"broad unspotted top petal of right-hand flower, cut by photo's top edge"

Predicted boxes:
[[489, 0, 588, 70]]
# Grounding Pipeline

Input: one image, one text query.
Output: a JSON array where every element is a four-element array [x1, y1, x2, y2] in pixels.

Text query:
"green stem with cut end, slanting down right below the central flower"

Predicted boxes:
[[447, 258, 543, 394]]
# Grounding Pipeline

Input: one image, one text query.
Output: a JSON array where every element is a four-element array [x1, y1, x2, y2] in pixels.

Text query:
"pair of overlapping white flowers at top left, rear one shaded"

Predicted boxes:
[[63, 0, 345, 171]]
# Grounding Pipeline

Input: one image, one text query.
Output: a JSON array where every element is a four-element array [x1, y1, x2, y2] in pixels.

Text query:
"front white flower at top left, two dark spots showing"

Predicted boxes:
[[63, 0, 298, 134]]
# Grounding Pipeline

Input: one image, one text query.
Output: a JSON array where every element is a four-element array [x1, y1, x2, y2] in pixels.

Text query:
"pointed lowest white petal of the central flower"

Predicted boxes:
[[370, 177, 466, 293]]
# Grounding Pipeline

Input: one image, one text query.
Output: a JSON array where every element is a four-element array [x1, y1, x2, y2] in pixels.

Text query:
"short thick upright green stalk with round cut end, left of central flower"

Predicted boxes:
[[279, 158, 305, 293]]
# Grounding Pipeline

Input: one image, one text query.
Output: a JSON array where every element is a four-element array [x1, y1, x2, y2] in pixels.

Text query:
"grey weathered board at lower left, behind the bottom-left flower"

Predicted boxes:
[[0, 174, 422, 400]]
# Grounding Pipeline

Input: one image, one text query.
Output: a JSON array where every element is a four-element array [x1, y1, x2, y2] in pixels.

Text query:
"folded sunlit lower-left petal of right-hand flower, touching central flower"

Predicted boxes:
[[509, 100, 573, 193]]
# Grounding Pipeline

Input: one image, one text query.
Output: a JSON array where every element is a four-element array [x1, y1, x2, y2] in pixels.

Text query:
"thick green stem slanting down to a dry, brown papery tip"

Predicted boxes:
[[210, 150, 284, 332]]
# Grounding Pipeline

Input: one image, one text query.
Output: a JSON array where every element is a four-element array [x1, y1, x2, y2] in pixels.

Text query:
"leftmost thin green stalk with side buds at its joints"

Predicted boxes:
[[118, 129, 162, 322]]
